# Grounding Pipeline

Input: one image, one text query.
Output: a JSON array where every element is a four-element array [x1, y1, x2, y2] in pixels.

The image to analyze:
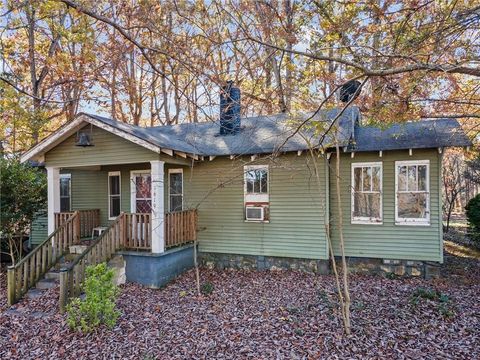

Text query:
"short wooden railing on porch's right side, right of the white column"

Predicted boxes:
[[165, 209, 197, 248]]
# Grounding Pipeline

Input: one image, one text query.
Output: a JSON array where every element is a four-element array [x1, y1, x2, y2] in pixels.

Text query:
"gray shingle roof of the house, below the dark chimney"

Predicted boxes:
[[81, 107, 471, 156]]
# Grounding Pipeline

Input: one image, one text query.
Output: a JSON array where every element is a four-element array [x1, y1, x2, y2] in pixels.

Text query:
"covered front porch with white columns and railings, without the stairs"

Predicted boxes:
[[47, 160, 197, 254]]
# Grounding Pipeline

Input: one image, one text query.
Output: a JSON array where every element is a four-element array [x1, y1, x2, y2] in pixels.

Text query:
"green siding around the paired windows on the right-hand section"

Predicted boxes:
[[330, 149, 443, 261]]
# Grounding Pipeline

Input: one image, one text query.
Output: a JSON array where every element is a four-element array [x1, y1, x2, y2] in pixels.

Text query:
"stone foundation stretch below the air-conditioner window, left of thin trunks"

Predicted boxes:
[[198, 253, 330, 274]]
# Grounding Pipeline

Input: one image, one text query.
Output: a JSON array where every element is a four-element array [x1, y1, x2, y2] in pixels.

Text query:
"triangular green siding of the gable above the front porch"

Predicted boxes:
[[45, 125, 176, 167]]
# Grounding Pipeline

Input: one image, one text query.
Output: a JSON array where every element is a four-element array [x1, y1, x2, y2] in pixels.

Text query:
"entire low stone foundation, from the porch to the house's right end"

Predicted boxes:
[[198, 253, 440, 279]]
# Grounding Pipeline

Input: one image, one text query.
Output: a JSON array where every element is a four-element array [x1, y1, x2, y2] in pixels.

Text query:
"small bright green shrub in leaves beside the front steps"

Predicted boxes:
[[67, 263, 120, 333]]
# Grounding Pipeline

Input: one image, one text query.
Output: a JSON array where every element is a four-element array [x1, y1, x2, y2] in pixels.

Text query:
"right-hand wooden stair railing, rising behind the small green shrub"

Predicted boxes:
[[59, 213, 126, 312]]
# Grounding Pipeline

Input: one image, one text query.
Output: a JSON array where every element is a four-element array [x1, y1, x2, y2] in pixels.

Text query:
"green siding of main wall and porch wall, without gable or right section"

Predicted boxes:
[[63, 155, 328, 259]]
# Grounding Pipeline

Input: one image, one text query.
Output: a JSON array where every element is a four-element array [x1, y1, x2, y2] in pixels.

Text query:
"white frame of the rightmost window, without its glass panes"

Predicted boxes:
[[395, 160, 430, 226]]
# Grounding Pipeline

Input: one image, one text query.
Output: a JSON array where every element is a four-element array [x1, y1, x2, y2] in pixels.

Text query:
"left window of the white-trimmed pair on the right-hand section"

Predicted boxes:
[[352, 162, 382, 224]]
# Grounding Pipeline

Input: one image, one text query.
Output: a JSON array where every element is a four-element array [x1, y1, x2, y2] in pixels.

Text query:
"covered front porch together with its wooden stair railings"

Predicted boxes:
[[8, 161, 198, 310]]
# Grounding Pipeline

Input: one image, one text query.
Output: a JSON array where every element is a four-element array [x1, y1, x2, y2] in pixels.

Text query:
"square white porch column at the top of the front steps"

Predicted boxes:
[[150, 160, 165, 254]]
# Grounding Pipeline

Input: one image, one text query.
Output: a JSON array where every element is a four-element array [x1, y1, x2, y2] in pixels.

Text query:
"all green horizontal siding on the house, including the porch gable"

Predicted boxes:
[[40, 123, 443, 261]]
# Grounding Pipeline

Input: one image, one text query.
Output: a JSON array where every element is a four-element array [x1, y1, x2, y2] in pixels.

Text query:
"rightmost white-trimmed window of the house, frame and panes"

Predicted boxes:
[[395, 160, 430, 225]]
